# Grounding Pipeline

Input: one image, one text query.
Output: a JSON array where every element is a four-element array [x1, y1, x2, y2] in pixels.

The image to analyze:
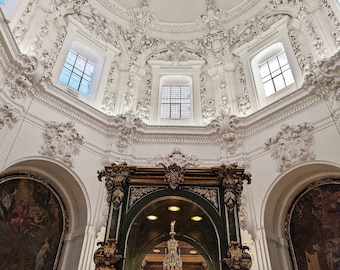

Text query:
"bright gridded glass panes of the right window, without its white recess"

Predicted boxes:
[[259, 52, 294, 97]]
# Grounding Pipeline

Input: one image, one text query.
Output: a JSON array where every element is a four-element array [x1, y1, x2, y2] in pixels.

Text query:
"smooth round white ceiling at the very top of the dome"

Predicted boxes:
[[93, 0, 260, 40]]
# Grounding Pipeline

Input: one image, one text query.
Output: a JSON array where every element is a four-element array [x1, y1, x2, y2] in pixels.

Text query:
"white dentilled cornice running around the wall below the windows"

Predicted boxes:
[[0, 0, 340, 156]]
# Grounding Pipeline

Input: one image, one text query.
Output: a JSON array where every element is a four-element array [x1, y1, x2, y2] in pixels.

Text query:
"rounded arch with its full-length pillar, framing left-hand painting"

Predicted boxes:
[[1, 157, 90, 269]]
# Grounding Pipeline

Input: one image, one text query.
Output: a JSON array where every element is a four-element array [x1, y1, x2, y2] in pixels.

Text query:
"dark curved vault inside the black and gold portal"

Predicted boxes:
[[125, 196, 219, 269]]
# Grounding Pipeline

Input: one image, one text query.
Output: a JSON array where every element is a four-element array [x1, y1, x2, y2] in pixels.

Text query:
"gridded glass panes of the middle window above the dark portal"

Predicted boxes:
[[160, 85, 191, 119]]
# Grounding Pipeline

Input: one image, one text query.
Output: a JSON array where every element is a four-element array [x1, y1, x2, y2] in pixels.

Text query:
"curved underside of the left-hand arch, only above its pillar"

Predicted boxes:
[[1, 157, 91, 233]]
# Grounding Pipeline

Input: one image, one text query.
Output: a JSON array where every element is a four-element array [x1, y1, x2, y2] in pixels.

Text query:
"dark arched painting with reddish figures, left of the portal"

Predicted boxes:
[[0, 175, 67, 270]]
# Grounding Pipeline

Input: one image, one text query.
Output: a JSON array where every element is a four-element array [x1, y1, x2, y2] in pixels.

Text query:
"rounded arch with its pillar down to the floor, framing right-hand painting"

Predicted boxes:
[[261, 161, 340, 270]]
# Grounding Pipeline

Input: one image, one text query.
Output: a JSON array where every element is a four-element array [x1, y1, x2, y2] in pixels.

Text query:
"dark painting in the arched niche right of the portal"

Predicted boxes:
[[286, 179, 340, 270]]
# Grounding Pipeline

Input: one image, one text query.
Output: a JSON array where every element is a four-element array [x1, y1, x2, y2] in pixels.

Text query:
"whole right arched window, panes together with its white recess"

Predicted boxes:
[[251, 42, 295, 97]]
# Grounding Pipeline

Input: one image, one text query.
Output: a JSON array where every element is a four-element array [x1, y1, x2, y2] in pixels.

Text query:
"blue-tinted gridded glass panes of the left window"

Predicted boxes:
[[59, 50, 94, 95]]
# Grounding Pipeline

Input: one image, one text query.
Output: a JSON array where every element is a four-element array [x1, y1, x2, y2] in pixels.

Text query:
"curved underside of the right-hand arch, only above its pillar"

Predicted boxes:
[[260, 161, 340, 238]]
